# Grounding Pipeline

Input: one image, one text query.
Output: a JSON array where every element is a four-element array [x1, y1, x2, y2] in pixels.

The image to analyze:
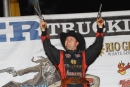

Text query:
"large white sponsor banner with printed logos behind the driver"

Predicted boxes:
[[0, 11, 130, 87]]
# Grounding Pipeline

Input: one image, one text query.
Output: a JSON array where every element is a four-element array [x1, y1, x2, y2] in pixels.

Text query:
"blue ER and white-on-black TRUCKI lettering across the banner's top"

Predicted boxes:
[[0, 16, 130, 42]]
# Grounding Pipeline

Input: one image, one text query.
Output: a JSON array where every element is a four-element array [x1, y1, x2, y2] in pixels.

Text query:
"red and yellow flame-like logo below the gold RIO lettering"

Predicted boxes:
[[118, 61, 130, 75]]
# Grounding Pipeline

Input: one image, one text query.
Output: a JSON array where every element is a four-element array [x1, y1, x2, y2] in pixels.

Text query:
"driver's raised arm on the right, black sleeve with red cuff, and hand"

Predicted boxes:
[[85, 18, 104, 66]]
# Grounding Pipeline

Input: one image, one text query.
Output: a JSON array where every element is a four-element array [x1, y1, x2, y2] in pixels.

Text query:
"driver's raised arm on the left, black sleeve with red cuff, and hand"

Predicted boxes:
[[40, 20, 60, 65]]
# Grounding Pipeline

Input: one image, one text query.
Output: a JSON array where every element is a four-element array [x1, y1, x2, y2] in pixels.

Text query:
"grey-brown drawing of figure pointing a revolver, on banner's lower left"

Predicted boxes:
[[0, 56, 60, 87]]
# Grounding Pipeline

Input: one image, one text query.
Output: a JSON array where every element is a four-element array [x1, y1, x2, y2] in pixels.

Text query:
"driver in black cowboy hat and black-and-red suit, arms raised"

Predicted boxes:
[[40, 18, 104, 87]]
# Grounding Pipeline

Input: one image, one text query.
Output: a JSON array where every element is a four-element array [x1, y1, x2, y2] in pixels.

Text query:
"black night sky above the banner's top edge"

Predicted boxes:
[[0, 0, 130, 17]]
